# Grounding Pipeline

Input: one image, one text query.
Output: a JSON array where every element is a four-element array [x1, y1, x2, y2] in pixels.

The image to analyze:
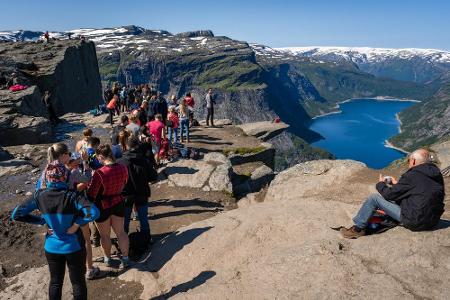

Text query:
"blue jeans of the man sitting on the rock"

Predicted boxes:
[[353, 193, 400, 229]]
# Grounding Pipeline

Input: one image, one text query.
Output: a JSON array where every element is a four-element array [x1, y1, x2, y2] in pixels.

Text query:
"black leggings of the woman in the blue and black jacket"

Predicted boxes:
[[45, 250, 87, 300]]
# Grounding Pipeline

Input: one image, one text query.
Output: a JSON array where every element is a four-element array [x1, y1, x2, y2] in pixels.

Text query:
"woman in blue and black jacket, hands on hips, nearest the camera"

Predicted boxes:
[[11, 143, 99, 300]]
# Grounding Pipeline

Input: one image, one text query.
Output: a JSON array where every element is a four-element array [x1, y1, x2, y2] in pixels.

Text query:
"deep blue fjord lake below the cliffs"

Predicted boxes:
[[310, 99, 415, 169]]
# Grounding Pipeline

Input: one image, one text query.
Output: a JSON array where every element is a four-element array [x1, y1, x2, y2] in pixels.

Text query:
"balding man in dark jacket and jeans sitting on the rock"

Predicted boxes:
[[341, 149, 445, 239]]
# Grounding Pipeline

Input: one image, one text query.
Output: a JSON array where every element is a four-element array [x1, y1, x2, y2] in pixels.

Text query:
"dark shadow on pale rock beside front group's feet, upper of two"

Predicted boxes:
[[146, 226, 213, 272]]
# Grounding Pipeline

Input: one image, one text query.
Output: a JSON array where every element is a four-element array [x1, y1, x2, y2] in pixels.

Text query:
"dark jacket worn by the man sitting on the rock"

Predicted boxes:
[[377, 163, 445, 231]]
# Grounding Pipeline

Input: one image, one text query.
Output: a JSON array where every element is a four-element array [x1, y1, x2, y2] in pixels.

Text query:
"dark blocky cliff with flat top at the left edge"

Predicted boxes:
[[0, 40, 102, 145]]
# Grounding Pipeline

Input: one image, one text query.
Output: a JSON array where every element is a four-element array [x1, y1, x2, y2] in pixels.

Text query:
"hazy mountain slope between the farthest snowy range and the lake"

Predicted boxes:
[[251, 44, 438, 116]]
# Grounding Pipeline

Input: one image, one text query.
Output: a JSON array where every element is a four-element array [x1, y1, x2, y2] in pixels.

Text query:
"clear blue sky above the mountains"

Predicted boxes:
[[0, 0, 450, 50]]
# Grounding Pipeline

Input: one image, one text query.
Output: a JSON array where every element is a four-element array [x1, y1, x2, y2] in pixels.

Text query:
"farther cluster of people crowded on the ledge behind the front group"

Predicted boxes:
[[104, 83, 215, 164]]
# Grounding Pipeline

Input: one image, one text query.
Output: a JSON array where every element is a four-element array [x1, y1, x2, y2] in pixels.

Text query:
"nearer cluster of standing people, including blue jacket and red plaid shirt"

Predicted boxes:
[[12, 125, 157, 299]]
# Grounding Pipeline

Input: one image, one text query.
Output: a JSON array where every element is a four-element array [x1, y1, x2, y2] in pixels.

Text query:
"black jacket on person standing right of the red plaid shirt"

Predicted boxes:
[[118, 149, 156, 203]]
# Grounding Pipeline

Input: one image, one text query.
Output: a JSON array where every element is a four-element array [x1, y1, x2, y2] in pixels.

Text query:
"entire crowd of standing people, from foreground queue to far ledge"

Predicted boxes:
[[7, 84, 214, 299]]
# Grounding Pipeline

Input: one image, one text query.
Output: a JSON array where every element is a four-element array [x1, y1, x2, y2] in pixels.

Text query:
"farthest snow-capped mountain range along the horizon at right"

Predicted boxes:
[[277, 47, 450, 83]]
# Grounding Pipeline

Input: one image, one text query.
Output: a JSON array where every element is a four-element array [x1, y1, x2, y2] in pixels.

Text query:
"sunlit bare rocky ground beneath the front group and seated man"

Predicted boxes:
[[0, 111, 450, 299]]
